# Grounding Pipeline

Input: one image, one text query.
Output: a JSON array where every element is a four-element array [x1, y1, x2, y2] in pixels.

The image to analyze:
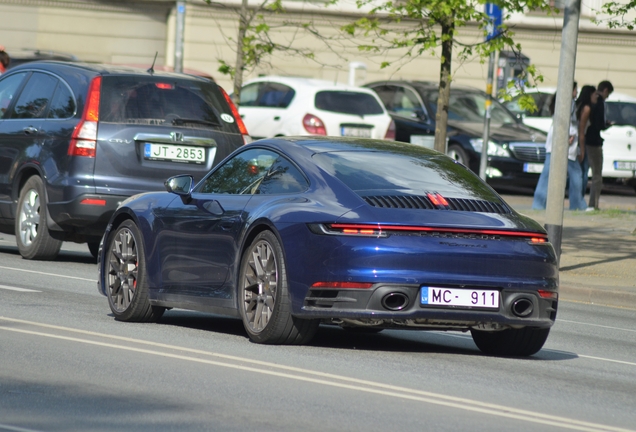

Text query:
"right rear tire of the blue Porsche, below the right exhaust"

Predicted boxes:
[[470, 327, 550, 357]]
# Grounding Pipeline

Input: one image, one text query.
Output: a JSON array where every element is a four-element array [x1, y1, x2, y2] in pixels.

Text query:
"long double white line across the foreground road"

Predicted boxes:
[[0, 317, 633, 432]]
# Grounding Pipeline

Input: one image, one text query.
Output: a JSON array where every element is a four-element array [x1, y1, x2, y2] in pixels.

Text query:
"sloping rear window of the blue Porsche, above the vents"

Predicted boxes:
[[313, 145, 501, 202]]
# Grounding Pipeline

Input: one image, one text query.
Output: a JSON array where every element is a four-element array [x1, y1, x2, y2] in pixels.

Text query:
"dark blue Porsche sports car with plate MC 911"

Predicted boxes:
[[98, 137, 558, 356]]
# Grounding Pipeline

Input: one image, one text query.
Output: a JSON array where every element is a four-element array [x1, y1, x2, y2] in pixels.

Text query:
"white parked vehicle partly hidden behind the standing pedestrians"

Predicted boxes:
[[506, 88, 636, 189]]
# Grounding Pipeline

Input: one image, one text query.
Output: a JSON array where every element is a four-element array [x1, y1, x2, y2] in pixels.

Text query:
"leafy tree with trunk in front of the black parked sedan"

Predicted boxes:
[[343, 0, 554, 153]]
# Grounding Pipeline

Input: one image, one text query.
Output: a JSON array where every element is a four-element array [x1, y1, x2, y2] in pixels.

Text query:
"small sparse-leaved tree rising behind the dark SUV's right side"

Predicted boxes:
[[205, 0, 313, 105]]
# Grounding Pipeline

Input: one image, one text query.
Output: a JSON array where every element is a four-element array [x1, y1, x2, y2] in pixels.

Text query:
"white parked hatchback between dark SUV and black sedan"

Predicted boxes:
[[239, 76, 395, 139]]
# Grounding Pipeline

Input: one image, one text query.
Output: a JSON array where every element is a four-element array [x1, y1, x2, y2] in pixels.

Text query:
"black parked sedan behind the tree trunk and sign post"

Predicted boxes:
[[365, 81, 546, 187]]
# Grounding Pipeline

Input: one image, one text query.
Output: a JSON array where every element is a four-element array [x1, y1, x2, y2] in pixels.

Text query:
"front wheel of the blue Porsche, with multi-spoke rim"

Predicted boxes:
[[104, 220, 166, 322]]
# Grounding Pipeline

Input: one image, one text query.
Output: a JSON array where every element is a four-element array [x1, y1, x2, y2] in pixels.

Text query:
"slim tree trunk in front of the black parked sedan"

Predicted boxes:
[[434, 16, 455, 154]]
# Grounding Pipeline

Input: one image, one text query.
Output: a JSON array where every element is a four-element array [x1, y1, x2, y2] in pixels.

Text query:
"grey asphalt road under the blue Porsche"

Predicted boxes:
[[0, 234, 636, 431]]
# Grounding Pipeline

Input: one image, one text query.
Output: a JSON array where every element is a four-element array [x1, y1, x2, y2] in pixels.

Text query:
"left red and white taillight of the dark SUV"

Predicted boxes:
[[68, 77, 102, 157]]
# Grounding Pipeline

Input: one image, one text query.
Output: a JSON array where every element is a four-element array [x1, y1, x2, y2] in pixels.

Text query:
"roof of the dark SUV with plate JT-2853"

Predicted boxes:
[[6, 60, 210, 82]]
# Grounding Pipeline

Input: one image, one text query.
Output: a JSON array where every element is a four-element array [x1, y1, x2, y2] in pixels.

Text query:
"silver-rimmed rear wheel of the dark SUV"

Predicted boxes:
[[15, 176, 62, 260]]
